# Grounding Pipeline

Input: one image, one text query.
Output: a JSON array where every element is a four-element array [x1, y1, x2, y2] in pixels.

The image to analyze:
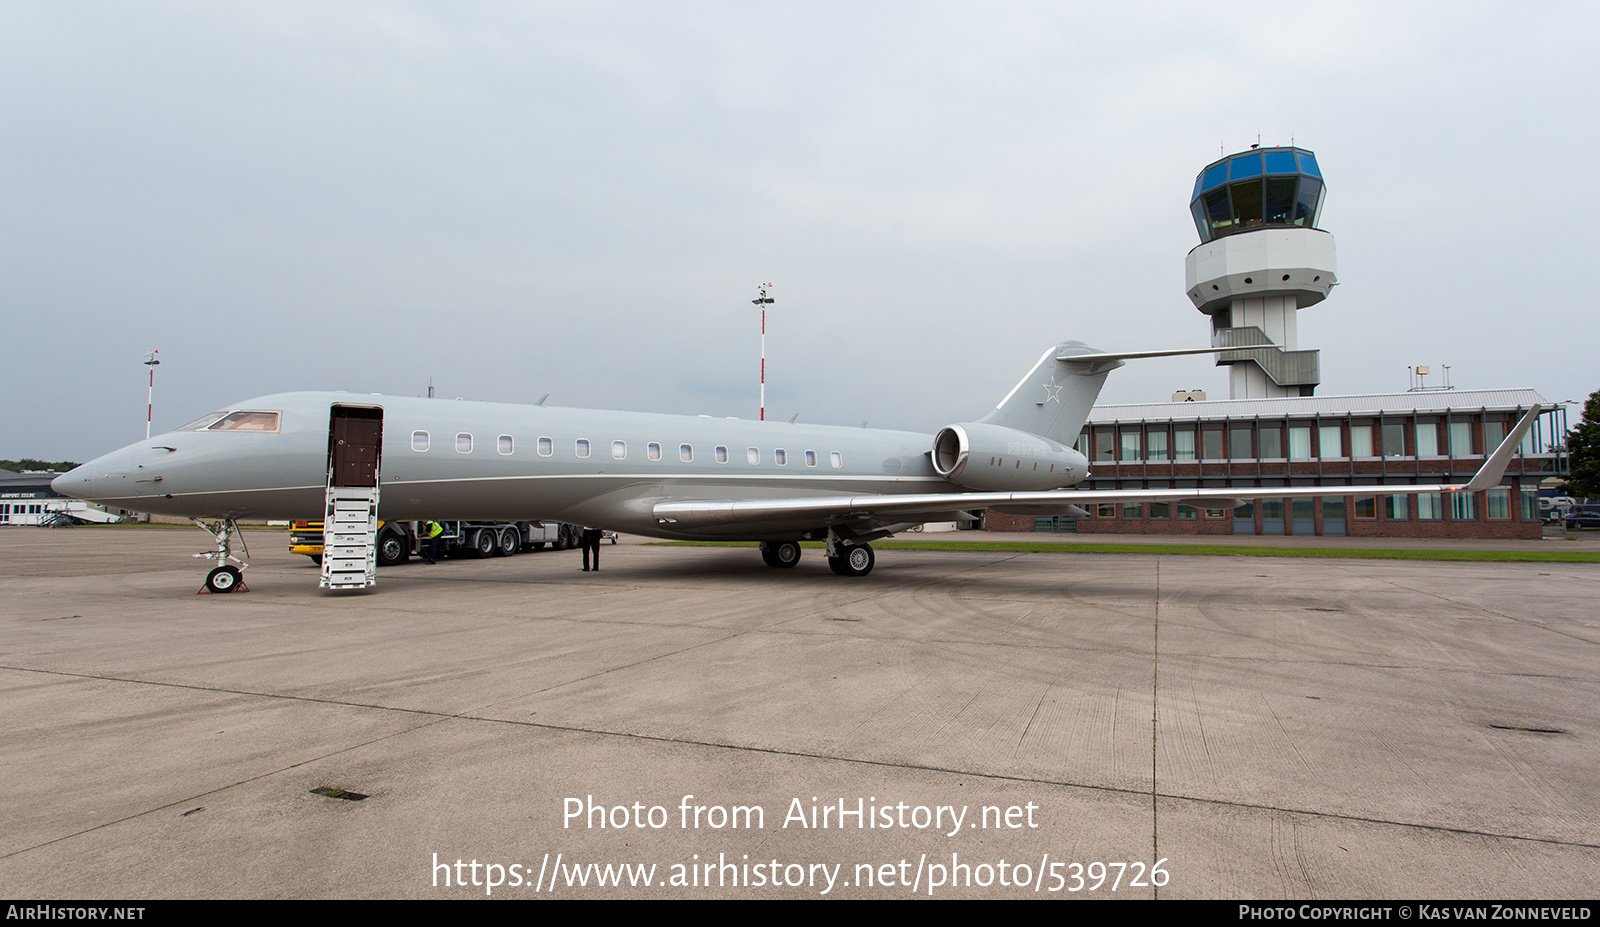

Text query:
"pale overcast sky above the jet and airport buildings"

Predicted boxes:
[[0, 0, 1600, 459]]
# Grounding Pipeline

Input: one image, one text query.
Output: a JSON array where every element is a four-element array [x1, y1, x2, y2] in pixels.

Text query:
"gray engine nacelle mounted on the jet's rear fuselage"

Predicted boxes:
[[933, 423, 1090, 493]]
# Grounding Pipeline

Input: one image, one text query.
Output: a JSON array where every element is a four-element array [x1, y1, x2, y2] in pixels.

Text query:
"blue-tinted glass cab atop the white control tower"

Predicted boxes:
[[1189, 147, 1326, 242]]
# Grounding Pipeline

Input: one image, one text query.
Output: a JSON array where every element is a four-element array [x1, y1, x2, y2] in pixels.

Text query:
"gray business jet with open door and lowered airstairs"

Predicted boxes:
[[53, 341, 1539, 591]]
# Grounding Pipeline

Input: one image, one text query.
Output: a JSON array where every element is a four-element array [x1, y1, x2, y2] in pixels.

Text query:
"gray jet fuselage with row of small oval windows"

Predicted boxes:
[[56, 392, 985, 540]]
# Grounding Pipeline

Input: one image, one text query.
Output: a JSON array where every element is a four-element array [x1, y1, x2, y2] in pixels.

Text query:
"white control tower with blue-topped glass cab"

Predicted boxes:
[[1184, 146, 1338, 399]]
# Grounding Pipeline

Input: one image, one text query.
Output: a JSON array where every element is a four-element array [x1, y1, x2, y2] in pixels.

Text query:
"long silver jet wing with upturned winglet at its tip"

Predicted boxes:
[[654, 407, 1541, 532]]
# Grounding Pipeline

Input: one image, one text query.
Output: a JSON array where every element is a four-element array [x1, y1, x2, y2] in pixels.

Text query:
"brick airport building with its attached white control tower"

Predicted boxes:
[[986, 147, 1568, 538]]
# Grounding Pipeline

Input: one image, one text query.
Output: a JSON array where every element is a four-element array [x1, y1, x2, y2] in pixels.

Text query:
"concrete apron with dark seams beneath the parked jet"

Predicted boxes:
[[0, 528, 1600, 900]]
